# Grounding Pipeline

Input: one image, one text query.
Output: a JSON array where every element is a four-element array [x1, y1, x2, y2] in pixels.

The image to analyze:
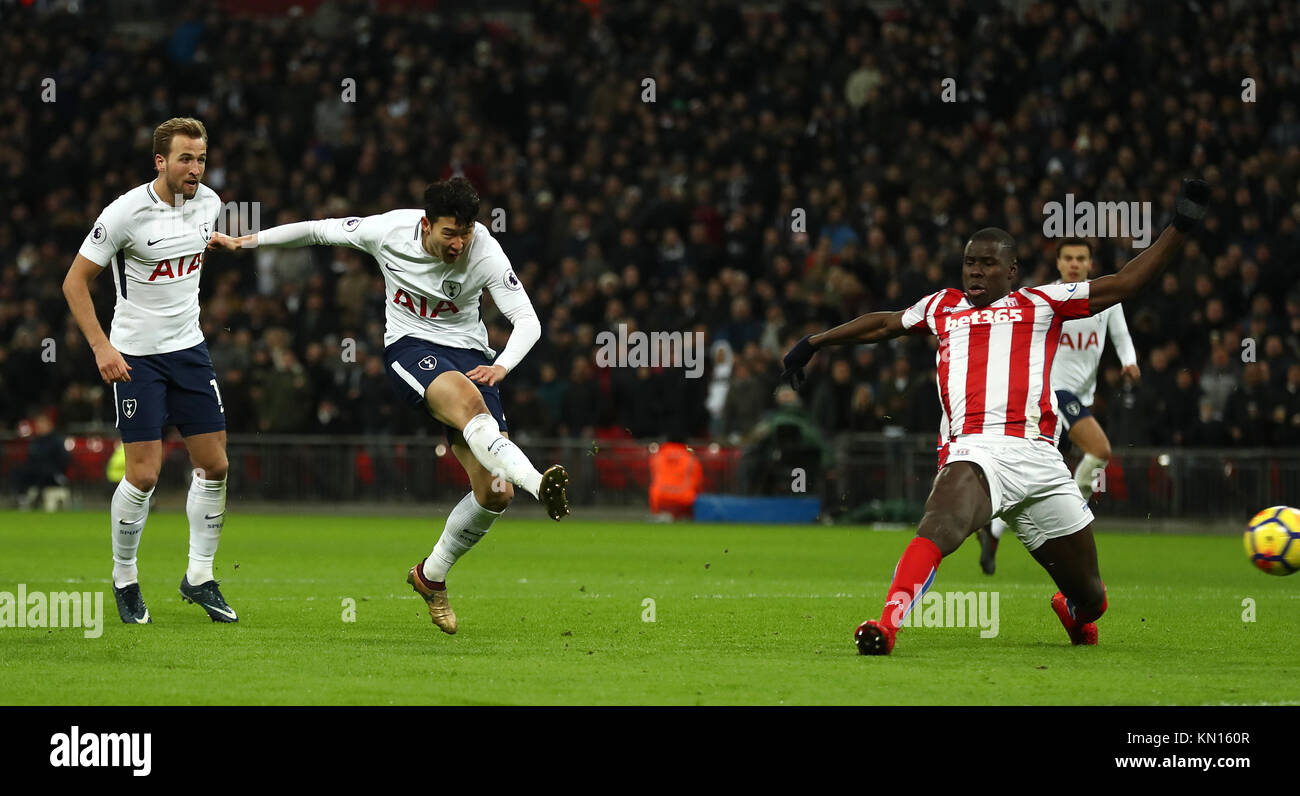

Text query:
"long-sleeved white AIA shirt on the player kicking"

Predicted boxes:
[[257, 209, 536, 356]]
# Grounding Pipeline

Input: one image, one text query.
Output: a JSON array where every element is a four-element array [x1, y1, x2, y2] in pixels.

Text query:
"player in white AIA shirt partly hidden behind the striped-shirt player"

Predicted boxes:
[[979, 238, 1141, 575]]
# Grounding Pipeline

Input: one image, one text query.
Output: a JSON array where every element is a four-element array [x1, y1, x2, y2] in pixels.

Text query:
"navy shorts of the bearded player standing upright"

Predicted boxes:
[[113, 342, 226, 442]]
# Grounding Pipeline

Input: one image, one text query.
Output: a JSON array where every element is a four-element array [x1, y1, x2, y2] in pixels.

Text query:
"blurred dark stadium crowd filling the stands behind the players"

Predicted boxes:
[[0, 0, 1300, 445]]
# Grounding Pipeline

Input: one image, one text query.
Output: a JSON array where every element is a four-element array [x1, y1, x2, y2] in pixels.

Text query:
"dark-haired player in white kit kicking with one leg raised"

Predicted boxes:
[[212, 178, 569, 633]]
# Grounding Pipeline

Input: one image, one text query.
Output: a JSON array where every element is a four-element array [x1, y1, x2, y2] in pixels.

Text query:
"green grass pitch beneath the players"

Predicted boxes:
[[0, 506, 1300, 705]]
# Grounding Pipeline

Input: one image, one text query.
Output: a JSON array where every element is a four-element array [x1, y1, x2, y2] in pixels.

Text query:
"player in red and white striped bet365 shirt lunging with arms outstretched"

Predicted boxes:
[[783, 179, 1210, 656]]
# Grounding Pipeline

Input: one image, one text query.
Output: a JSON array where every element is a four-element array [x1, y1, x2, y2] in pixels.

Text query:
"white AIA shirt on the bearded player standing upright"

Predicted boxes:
[[78, 182, 221, 356]]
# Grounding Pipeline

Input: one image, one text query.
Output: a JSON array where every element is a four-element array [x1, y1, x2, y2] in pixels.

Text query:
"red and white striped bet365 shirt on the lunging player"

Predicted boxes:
[[902, 282, 1089, 455]]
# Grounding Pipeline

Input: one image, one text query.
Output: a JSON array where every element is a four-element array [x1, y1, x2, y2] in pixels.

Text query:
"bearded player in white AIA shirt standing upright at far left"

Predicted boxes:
[[64, 118, 238, 624]]
